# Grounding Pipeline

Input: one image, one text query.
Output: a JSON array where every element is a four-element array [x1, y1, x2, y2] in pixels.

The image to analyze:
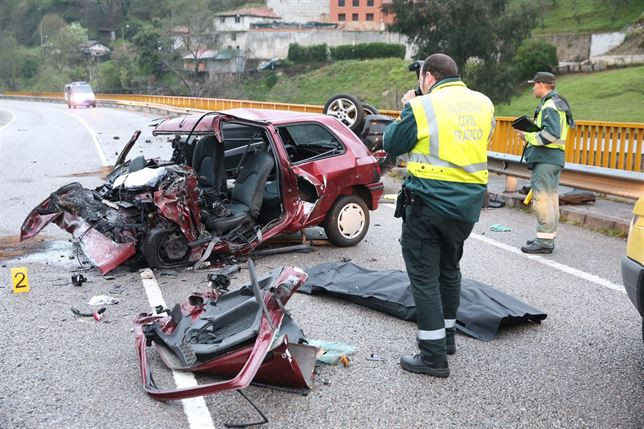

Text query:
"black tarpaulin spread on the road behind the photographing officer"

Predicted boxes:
[[298, 262, 547, 341]]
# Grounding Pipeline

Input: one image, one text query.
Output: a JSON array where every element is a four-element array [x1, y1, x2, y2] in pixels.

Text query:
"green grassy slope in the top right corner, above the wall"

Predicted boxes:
[[511, 0, 644, 34]]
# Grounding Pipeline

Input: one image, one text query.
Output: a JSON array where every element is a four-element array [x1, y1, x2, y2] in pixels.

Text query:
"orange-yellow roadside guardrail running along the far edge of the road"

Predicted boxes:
[[4, 92, 644, 198]]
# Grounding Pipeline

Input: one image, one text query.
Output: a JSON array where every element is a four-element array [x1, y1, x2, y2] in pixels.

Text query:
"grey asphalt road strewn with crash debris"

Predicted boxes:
[[0, 100, 644, 428]]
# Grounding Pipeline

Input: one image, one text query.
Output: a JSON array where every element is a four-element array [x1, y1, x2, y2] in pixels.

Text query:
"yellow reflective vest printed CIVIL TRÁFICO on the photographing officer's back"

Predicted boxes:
[[407, 80, 495, 184]]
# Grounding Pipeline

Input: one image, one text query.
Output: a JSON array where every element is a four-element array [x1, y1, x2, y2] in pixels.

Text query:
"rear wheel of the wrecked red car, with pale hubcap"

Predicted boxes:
[[324, 195, 369, 247]]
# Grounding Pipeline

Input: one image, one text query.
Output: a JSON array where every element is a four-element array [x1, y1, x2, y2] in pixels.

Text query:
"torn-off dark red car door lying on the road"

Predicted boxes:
[[134, 259, 320, 400]]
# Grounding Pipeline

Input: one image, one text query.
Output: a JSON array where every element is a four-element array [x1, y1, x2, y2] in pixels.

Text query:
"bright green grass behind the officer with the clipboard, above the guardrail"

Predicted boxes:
[[496, 66, 644, 122]]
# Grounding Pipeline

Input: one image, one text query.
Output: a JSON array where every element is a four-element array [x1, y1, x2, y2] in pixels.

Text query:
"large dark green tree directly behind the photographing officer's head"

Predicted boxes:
[[384, 0, 536, 101]]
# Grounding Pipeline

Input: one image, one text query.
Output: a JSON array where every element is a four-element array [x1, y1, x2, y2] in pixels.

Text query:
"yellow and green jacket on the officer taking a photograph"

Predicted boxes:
[[383, 77, 495, 222]]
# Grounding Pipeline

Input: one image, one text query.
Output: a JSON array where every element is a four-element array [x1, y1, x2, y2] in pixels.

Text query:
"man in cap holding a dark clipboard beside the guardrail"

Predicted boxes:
[[518, 72, 575, 253]]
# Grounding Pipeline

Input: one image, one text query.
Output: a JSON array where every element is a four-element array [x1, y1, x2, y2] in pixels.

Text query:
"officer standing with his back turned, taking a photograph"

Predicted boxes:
[[383, 54, 495, 377]]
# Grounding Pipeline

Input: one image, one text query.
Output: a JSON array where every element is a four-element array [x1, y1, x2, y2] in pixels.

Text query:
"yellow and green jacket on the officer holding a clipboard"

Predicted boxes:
[[525, 91, 575, 167]]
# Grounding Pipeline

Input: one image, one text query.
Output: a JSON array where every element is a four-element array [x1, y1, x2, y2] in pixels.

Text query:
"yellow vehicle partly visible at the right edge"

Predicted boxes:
[[622, 197, 644, 341]]
